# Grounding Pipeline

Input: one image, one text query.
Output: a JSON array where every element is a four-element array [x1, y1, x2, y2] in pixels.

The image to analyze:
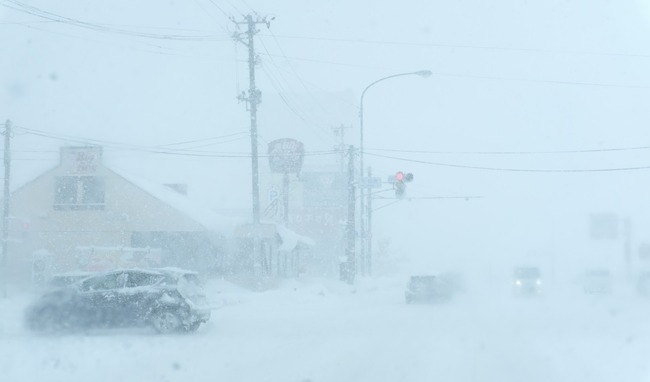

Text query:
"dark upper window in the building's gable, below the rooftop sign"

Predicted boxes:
[[54, 176, 105, 210]]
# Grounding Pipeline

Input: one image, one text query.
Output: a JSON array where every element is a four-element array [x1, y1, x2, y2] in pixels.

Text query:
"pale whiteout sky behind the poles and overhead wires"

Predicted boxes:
[[0, 0, 650, 274]]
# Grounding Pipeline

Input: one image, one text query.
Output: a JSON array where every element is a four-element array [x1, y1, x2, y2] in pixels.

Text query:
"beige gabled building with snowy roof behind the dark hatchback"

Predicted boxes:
[[7, 147, 241, 282]]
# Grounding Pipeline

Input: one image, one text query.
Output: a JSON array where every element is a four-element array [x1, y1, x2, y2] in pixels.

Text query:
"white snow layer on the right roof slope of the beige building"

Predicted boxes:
[[109, 167, 246, 234]]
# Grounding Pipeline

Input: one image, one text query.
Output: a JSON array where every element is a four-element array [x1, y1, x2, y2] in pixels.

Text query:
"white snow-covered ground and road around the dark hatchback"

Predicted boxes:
[[0, 279, 650, 382]]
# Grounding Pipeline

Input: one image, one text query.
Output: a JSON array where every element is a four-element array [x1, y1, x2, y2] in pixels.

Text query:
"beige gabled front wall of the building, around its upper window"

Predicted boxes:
[[7, 152, 214, 283]]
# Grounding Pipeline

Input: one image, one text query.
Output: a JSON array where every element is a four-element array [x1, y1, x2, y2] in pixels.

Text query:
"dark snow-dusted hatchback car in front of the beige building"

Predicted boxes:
[[25, 268, 210, 333]]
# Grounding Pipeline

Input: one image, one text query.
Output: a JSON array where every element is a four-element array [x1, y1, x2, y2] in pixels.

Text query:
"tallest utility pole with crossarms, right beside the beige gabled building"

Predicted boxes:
[[232, 14, 270, 278]]
